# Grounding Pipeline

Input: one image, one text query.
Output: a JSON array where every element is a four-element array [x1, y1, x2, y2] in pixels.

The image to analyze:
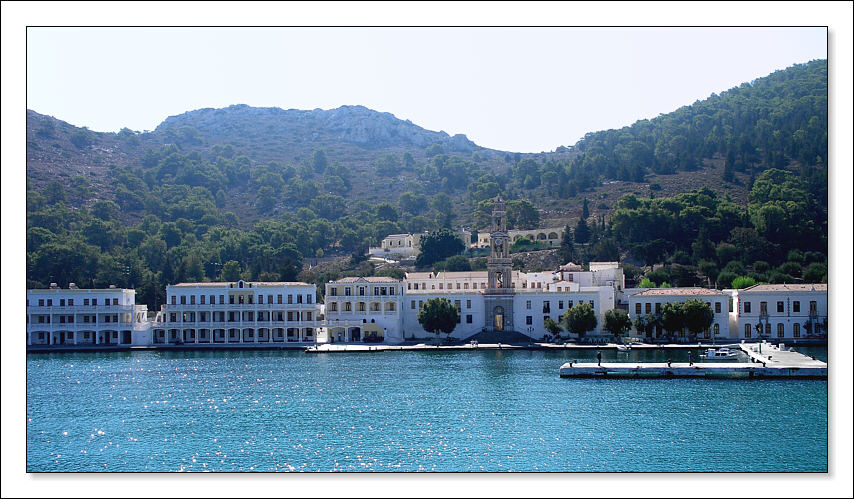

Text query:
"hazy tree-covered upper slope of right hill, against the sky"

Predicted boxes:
[[572, 60, 827, 185]]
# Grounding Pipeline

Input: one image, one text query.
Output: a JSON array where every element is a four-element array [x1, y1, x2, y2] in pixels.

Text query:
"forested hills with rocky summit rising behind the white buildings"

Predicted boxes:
[[27, 60, 827, 306]]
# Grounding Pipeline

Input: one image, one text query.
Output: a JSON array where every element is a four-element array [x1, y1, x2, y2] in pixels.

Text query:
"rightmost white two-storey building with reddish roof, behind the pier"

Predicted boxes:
[[733, 284, 827, 342]]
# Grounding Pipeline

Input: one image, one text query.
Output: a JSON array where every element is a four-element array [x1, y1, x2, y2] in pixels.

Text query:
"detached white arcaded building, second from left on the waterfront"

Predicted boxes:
[[150, 281, 321, 345]]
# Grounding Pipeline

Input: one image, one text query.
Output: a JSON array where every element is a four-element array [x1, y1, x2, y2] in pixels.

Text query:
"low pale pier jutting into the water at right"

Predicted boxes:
[[560, 343, 827, 379]]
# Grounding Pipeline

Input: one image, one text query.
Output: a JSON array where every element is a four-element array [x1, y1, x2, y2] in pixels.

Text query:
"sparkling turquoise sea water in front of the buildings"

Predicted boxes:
[[27, 349, 828, 472]]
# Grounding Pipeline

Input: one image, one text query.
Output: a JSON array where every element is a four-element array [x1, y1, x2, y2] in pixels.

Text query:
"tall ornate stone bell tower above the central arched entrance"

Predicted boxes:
[[483, 196, 514, 331]]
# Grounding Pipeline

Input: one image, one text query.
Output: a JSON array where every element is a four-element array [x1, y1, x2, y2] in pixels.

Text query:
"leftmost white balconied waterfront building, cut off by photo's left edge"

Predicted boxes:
[[27, 283, 148, 346]]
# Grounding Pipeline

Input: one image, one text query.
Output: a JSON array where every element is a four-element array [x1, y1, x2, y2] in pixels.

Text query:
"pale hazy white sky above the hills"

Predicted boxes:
[[26, 27, 827, 152]]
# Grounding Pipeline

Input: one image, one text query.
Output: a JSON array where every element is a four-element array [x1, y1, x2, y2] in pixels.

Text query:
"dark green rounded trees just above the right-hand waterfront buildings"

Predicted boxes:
[[610, 175, 827, 287]]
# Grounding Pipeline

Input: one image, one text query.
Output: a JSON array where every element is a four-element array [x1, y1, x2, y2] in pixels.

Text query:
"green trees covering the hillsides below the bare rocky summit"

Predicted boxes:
[[26, 61, 828, 308]]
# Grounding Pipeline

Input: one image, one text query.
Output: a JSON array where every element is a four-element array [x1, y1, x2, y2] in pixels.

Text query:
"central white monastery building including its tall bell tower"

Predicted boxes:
[[325, 198, 612, 343]]
